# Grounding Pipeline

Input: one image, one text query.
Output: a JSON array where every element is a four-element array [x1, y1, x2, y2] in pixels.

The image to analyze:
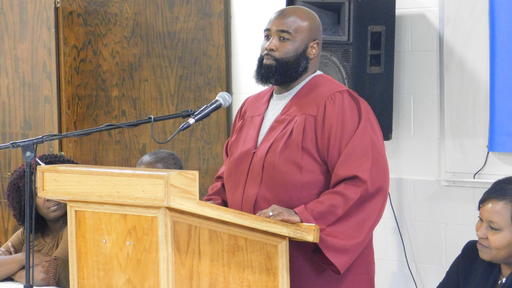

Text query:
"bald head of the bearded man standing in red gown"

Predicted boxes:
[[255, 6, 322, 87]]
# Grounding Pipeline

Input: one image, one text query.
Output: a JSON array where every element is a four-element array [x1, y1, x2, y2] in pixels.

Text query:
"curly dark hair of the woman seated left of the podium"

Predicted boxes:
[[6, 154, 77, 233]]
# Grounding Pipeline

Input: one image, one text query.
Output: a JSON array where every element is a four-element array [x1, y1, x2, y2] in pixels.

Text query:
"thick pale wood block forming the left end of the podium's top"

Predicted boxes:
[[37, 164, 199, 206]]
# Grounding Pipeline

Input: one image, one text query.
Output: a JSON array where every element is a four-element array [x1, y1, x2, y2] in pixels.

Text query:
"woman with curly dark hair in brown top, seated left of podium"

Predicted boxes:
[[0, 154, 76, 287]]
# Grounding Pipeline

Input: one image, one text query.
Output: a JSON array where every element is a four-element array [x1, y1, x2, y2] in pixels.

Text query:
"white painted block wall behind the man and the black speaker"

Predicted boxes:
[[231, 0, 512, 288]]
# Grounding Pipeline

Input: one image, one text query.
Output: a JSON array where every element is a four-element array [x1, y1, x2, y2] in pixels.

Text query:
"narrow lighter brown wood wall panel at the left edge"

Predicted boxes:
[[0, 0, 59, 243]]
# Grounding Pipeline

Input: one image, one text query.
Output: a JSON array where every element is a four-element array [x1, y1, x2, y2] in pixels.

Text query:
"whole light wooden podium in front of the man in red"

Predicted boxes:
[[36, 165, 319, 288]]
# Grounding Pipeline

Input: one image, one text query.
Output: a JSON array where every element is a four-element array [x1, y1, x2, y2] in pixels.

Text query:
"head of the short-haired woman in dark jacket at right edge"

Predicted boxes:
[[476, 177, 512, 266]]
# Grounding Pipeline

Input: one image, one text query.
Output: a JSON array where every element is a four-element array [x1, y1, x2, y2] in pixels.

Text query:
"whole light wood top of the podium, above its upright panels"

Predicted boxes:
[[36, 164, 320, 242]]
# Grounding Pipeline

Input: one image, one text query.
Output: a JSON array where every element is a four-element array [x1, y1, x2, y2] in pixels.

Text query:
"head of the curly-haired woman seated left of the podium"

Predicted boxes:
[[6, 154, 77, 233]]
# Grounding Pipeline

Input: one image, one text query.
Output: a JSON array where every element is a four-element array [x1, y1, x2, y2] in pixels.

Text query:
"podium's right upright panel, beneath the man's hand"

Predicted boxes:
[[171, 213, 290, 288]]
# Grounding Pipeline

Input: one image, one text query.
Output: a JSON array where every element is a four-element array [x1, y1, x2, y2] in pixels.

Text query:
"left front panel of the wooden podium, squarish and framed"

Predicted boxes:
[[68, 203, 169, 288]]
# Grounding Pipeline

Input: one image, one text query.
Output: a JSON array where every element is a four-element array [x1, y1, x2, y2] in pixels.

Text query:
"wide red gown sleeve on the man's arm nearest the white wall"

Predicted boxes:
[[295, 90, 389, 272]]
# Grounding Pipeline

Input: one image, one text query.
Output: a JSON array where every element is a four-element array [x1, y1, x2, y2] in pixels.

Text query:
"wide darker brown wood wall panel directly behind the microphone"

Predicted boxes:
[[59, 0, 228, 194]]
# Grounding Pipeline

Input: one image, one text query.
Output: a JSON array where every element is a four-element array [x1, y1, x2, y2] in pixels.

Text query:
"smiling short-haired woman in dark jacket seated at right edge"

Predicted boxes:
[[437, 177, 512, 288]]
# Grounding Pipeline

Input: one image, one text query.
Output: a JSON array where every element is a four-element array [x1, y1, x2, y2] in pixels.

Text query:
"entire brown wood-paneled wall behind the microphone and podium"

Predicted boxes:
[[0, 0, 229, 243]]
